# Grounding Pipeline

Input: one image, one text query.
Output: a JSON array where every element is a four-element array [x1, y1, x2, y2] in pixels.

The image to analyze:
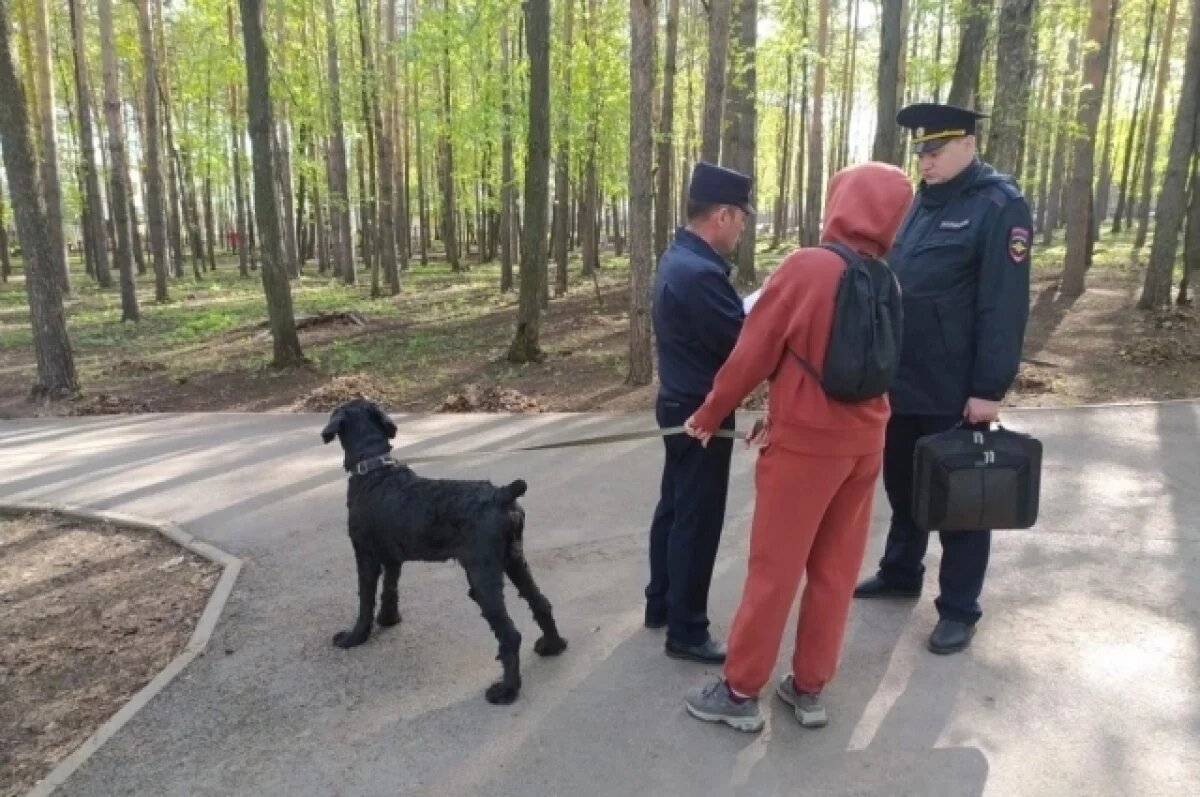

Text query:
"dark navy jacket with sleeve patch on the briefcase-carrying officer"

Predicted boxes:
[[888, 161, 1032, 415]]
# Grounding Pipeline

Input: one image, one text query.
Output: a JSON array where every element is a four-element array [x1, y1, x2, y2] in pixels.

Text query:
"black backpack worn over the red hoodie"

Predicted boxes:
[[792, 244, 904, 402]]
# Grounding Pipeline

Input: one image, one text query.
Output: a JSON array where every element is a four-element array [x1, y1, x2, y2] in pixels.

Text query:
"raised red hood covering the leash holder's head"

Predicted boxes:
[[821, 162, 912, 257]]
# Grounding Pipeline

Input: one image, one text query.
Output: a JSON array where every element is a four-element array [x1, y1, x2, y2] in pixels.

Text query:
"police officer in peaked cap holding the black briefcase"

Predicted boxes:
[[854, 103, 1032, 653]]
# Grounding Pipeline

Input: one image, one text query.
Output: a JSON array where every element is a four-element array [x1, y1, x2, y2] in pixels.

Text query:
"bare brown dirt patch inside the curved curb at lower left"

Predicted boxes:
[[0, 515, 220, 797]]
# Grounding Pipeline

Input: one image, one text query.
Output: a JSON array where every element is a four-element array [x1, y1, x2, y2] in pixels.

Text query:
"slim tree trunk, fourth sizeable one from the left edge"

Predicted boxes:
[[98, 0, 139, 322]]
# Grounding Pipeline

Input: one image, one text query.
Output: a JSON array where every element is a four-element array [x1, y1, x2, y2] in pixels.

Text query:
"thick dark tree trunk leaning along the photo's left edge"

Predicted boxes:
[[0, 0, 77, 400]]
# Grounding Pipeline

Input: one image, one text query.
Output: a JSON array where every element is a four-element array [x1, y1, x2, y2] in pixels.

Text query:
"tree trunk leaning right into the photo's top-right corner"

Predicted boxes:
[[1138, 1, 1200, 310]]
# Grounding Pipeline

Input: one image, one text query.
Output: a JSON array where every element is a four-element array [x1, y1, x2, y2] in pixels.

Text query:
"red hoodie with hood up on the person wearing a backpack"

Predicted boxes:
[[692, 163, 912, 456]]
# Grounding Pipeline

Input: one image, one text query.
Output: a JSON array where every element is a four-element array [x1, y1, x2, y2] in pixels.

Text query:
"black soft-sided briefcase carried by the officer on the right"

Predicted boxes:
[[912, 425, 1042, 531]]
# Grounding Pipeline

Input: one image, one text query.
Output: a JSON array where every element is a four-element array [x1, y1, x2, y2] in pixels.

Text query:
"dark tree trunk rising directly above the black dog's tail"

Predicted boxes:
[[509, 0, 554, 362]]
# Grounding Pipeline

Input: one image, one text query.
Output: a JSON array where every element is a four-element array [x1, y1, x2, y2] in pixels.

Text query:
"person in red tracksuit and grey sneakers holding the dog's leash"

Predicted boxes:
[[685, 163, 912, 731]]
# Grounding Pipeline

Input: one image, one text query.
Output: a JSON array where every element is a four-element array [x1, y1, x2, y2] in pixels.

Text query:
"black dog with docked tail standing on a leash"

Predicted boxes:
[[320, 399, 566, 703]]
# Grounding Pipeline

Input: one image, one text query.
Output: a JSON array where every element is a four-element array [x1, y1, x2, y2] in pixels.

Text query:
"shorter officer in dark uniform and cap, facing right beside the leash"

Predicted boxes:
[[646, 162, 754, 663]]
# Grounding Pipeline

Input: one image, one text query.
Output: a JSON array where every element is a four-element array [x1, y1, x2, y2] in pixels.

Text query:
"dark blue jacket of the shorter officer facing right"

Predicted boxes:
[[650, 228, 745, 403]]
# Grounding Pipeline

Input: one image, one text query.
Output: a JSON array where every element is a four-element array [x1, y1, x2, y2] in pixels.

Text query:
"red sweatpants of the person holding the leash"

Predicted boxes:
[[725, 447, 883, 695]]
